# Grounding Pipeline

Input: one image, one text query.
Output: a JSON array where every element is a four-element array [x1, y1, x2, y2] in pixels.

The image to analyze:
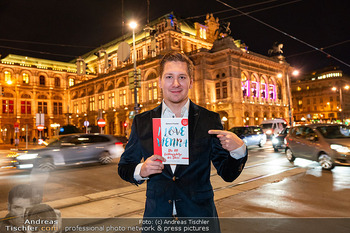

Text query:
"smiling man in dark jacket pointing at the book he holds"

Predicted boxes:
[[118, 53, 247, 228]]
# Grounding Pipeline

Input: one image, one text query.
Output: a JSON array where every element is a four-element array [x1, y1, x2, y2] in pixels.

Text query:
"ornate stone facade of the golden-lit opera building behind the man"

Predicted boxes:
[[0, 14, 290, 143]]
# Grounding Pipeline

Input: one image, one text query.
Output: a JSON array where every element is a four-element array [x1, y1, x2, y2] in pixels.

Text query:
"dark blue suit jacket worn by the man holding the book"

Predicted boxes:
[[118, 102, 247, 217]]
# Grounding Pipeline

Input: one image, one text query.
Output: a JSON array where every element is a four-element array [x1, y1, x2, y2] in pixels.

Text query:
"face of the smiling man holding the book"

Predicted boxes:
[[159, 61, 193, 105]]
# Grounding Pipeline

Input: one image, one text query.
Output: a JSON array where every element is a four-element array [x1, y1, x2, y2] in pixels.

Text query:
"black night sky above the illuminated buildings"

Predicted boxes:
[[0, 0, 350, 74]]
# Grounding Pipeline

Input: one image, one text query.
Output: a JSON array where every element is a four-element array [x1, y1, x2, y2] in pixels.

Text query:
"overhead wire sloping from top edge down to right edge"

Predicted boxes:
[[215, 0, 350, 67]]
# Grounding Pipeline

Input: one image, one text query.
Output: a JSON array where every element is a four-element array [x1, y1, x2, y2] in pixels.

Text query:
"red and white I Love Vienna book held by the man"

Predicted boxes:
[[153, 118, 189, 165]]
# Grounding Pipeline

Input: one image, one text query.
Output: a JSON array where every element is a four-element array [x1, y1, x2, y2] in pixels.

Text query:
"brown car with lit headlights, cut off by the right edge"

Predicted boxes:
[[286, 124, 350, 170]]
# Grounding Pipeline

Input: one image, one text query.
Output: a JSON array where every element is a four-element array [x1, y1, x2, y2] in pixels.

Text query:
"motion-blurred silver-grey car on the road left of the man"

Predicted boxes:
[[13, 134, 124, 171]]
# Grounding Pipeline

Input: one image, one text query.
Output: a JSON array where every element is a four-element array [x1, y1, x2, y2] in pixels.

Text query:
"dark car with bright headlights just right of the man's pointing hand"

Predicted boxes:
[[230, 126, 266, 147]]
